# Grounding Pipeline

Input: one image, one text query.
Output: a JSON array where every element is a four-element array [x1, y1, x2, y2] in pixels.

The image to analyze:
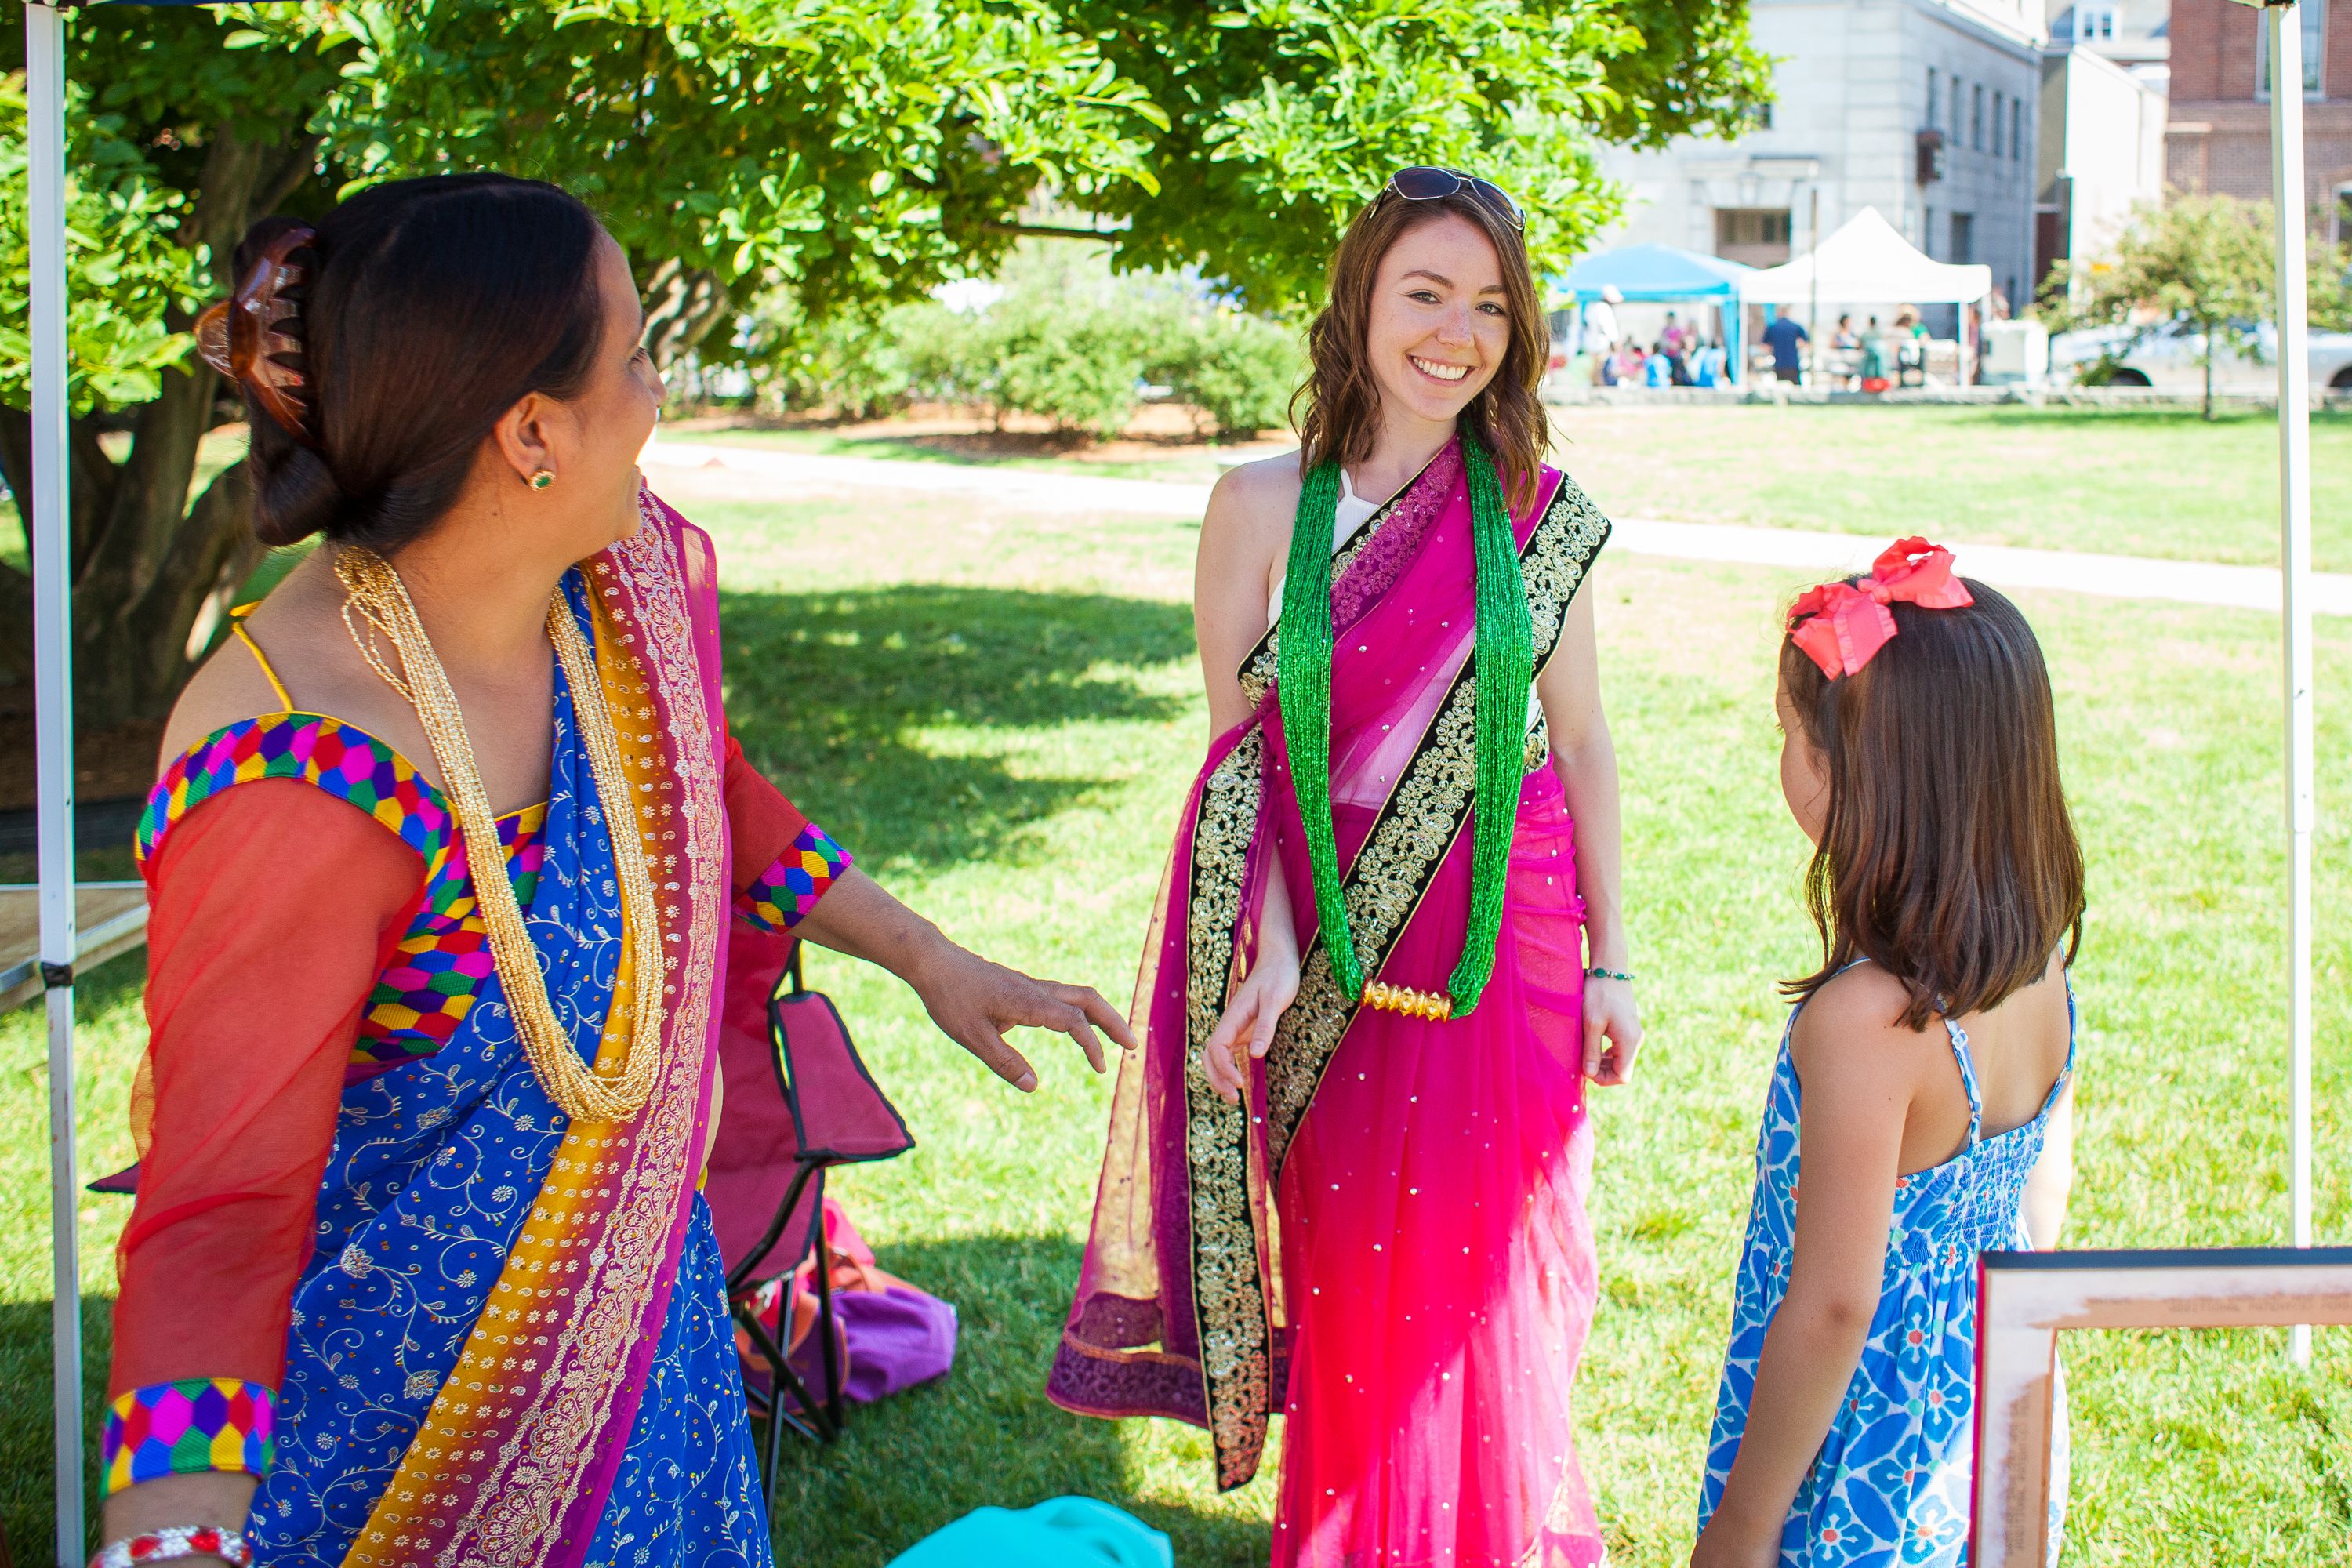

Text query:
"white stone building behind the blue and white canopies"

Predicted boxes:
[[1602, 0, 2051, 332]]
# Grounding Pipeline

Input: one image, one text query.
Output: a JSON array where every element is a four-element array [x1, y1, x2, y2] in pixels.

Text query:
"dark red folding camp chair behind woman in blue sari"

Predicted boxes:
[[703, 928, 915, 1493]]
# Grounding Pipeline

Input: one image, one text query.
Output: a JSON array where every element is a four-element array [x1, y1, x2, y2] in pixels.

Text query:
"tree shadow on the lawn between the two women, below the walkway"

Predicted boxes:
[[722, 586, 1192, 867]]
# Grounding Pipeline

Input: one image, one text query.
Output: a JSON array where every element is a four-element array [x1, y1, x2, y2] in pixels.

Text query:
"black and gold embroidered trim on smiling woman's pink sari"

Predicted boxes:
[[1185, 475, 1609, 1490]]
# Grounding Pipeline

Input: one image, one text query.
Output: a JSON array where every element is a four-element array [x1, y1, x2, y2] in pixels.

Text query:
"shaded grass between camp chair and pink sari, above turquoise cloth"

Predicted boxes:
[[774, 1236, 1272, 1568]]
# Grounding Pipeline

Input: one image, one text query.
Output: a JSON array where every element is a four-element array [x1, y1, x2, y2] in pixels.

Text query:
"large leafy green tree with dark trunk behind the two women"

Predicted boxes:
[[0, 0, 1762, 720]]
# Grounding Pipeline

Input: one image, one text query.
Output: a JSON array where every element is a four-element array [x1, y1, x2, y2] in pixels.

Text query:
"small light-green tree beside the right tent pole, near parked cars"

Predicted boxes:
[[2044, 195, 2352, 419]]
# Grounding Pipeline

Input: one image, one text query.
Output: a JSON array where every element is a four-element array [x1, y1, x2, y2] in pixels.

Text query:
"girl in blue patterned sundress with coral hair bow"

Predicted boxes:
[[1691, 539, 2084, 1568]]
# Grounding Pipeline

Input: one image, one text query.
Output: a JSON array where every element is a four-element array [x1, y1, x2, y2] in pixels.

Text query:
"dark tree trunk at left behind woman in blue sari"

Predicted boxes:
[[0, 120, 318, 729]]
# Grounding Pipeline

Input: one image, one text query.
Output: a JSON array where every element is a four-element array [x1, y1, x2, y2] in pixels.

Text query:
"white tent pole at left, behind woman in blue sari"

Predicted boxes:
[[24, 0, 85, 1566]]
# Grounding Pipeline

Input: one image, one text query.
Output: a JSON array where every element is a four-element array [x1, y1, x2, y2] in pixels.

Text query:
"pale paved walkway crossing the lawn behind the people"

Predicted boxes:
[[644, 442, 2352, 616]]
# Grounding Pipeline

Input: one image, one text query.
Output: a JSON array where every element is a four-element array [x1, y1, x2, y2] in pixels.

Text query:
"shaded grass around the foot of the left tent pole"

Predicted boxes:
[[0, 1295, 115, 1568]]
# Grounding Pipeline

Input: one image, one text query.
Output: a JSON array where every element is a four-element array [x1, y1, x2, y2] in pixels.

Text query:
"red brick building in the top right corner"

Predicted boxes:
[[2164, 0, 2352, 240]]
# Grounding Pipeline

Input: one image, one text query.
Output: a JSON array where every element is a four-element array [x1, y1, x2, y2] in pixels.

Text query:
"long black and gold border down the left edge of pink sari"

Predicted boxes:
[[1183, 729, 1272, 1490]]
